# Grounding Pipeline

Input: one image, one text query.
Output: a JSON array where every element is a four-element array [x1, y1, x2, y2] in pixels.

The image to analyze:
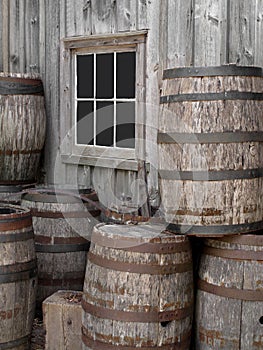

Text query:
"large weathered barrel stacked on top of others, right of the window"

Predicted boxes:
[[158, 65, 263, 236]]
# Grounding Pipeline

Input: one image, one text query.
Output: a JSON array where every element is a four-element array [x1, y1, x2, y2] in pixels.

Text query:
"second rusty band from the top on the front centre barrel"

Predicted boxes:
[[88, 252, 192, 275]]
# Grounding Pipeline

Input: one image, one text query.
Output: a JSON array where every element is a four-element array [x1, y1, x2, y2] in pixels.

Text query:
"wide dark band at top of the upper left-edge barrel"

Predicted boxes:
[[0, 77, 44, 95]]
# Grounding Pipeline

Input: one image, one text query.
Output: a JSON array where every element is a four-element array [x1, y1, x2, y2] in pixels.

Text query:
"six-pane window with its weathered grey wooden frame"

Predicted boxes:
[[61, 31, 146, 170]]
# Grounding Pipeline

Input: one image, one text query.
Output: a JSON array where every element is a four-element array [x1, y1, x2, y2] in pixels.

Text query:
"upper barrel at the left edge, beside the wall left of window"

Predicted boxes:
[[0, 73, 46, 184]]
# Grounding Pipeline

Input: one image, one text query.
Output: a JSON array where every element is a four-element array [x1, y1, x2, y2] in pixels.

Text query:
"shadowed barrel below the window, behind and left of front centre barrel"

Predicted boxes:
[[21, 189, 97, 306]]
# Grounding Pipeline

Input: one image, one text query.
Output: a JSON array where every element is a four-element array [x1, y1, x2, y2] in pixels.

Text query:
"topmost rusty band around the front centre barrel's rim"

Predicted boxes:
[[91, 231, 191, 254]]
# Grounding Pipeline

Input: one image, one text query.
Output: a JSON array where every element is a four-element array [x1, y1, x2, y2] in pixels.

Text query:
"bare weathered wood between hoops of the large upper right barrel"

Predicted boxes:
[[159, 71, 263, 230]]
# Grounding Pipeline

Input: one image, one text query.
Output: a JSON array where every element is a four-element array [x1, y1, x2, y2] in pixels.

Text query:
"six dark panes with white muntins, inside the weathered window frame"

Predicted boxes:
[[75, 50, 136, 148]]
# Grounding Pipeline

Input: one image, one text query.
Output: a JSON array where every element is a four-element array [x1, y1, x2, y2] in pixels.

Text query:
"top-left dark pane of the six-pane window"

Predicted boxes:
[[77, 55, 94, 98]]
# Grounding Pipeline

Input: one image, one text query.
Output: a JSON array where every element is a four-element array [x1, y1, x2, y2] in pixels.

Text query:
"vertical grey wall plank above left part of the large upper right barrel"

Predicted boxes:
[[167, 0, 193, 68]]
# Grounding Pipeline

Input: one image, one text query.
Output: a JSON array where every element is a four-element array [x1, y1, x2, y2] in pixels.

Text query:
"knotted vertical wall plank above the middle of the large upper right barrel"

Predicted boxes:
[[193, 0, 227, 66]]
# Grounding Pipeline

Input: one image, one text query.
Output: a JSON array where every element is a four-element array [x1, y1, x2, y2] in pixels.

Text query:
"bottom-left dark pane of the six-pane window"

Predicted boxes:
[[77, 101, 94, 145]]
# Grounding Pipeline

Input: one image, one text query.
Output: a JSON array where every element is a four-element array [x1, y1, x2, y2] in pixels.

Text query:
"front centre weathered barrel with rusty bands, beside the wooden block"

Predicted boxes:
[[82, 223, 193, 350]]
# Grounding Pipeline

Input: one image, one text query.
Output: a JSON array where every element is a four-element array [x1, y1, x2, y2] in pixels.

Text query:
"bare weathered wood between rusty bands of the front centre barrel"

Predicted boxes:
[[82, 224, 193, 349]]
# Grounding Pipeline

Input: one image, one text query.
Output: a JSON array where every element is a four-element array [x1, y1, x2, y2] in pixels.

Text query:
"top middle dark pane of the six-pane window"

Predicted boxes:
[[96, 53, 114, 98]]
